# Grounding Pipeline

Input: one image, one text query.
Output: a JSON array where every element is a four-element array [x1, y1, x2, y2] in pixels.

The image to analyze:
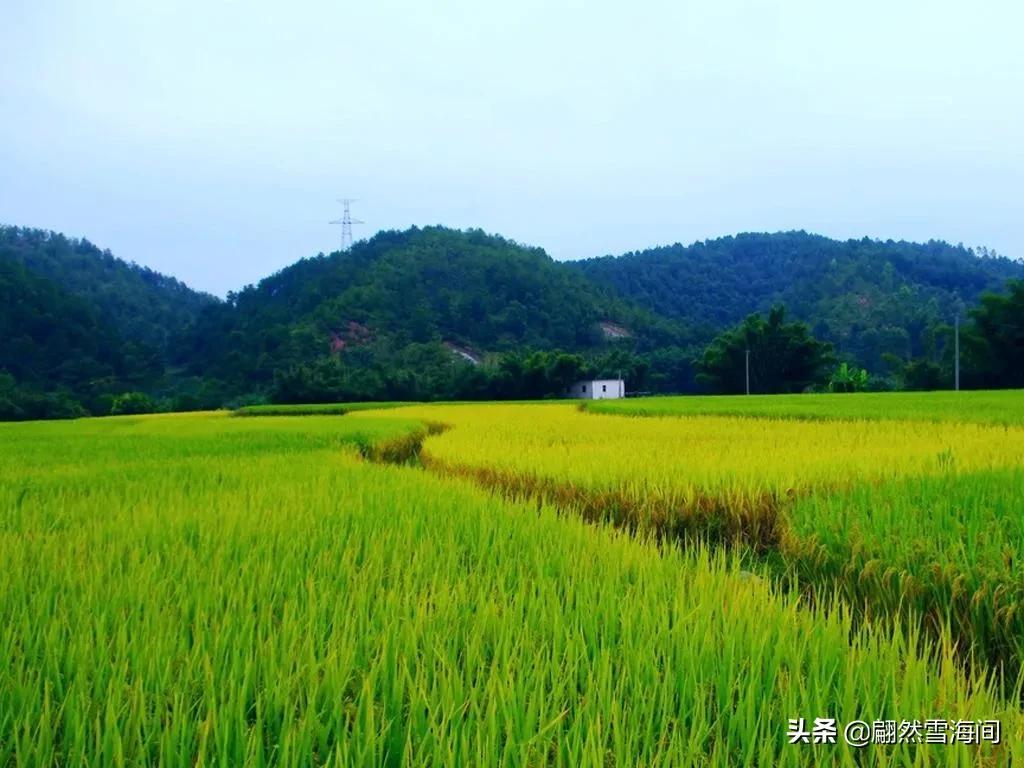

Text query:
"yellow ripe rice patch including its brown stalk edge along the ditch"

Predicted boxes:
[[354, 404, 1024, 549]]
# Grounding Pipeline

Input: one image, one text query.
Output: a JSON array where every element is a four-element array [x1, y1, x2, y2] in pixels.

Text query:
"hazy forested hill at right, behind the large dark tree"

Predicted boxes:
[[571, 231, 1024, 372]]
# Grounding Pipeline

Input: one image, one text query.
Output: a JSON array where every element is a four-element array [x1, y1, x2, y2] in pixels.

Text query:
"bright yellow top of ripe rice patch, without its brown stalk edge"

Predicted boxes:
[[372, 404, 1024, 496]]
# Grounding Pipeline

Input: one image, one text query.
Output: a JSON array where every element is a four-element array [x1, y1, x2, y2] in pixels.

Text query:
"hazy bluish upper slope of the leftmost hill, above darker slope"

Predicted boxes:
[[0, 226, 217, 353]]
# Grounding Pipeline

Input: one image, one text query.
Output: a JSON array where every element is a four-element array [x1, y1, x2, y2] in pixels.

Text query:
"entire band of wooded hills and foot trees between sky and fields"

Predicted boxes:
[[0, 227, 1024, 419]]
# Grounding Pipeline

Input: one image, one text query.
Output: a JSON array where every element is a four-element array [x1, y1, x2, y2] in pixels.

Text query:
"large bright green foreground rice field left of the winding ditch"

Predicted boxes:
[[0, 412, 1024, 766]]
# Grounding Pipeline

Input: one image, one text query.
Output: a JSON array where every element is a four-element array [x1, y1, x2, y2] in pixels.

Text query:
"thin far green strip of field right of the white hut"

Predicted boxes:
[[585, 390, 1024, 426]]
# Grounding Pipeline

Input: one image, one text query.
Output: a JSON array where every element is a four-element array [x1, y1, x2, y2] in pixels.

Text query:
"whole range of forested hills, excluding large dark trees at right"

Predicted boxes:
[[0, 226, 1024, 418]]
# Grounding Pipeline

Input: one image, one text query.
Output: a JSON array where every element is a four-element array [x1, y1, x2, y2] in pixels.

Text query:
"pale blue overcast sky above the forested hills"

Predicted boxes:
[[0, 0, 1024, 294]]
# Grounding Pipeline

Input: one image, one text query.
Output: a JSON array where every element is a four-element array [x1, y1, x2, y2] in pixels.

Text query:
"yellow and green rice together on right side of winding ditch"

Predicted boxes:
[[353, 403, 1024, 687]]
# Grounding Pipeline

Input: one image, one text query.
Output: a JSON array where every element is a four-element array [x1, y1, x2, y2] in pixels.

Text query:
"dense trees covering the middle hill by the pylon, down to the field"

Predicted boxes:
[[178, 227, 689, 401]]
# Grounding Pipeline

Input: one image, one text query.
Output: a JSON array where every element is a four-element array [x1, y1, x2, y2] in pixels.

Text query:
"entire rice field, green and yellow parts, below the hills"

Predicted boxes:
[[0, 395, 1024, 766]]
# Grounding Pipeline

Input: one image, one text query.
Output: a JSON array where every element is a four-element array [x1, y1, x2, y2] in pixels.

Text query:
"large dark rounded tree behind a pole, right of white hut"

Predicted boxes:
[[697, 306, 831, 394]]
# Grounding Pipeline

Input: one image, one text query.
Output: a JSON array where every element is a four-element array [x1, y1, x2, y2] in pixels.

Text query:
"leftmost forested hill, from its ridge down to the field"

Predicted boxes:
[[0, 226, 216, 419]]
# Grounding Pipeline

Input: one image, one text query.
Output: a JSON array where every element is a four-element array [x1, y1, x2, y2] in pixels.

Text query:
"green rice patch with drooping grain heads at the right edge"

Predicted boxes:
[[781, 467, 1024, 676]]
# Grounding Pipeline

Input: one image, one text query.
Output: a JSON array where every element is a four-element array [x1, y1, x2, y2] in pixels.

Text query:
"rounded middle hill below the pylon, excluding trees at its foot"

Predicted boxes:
[[180, 227, 680, 387]]
